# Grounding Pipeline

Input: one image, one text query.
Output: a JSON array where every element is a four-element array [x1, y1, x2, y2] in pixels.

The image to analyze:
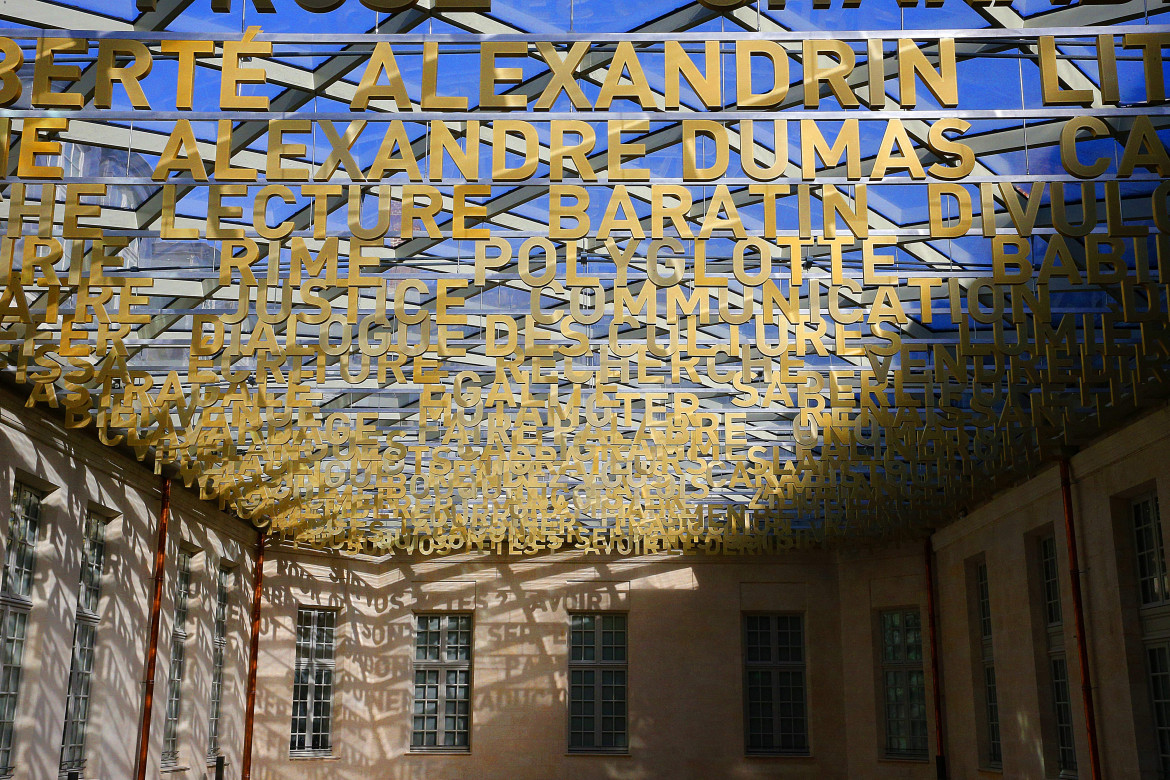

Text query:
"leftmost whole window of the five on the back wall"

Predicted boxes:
[[289, 607, 337, 755]]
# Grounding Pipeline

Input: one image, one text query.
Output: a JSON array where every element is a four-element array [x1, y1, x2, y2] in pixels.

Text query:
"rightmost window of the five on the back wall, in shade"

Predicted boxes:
[[881, 609, 927, 758]]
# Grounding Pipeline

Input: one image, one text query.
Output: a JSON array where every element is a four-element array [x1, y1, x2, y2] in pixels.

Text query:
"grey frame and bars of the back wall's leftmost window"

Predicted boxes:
[[289, 605, 340, 758]]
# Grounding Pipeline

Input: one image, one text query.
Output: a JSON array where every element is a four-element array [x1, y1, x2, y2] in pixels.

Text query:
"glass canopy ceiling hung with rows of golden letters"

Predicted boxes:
[[0, 0, 1170, 554]]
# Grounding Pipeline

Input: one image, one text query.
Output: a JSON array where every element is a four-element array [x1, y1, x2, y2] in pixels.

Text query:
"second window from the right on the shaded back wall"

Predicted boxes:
[[743, 615, 808, 755]]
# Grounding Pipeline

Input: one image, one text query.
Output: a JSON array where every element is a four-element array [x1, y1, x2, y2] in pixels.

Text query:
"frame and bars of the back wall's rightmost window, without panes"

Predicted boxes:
[[874, 606, 930, 761]]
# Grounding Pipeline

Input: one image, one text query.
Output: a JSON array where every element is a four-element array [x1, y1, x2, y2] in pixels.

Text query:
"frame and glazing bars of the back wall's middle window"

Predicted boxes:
[[565, 609, 629, 755]]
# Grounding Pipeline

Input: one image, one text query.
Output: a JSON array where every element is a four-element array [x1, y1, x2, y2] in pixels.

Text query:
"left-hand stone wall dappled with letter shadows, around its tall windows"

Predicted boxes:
[[0, 395, 257, 780]]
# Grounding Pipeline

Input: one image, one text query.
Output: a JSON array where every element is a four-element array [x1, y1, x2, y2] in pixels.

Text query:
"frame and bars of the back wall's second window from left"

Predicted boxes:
[[410, 612, 475, 753]]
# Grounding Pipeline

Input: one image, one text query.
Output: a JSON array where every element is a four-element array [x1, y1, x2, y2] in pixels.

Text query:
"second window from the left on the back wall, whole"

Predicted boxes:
[[411, 614, 472, 751]]
